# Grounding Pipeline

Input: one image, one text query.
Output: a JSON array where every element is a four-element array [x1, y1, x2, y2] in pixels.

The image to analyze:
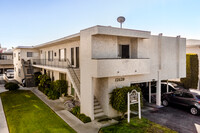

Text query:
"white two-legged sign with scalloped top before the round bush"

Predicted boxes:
[[127, 90, 141, 123]]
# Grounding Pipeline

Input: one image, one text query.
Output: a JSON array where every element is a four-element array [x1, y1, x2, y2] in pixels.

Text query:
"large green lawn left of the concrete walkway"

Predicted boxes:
[[0, 90, 75, 133]]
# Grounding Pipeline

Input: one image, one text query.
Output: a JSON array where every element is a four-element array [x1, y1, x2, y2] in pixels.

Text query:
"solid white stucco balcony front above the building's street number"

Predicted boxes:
[[93, 58, 150, 78]]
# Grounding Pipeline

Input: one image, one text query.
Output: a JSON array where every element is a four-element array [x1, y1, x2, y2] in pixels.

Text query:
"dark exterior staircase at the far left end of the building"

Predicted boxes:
[[21, 59, 35, 87]]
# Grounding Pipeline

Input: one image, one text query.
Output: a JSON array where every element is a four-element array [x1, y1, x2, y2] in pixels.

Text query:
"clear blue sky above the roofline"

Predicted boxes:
[[0, 0, 200, 48]]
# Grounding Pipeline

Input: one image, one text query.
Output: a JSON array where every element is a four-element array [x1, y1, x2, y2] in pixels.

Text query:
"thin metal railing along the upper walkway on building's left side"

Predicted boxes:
[[33, 59, 70, 68]]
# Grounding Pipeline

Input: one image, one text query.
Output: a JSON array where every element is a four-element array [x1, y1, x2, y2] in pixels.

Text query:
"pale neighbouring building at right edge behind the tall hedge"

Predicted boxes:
[[186, 39, 200, 90]]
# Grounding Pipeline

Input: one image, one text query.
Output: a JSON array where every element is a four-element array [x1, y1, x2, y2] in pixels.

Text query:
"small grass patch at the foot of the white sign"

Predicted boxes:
[[100, 118, 177, 133]]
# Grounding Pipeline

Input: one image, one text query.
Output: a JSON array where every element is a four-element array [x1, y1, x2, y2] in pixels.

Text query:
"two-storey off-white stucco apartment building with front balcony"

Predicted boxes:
[[14, 26, 186, 119]]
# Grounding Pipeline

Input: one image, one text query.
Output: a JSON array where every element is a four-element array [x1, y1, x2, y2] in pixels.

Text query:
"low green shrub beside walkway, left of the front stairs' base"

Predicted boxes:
[[71, 106, 91, 123]]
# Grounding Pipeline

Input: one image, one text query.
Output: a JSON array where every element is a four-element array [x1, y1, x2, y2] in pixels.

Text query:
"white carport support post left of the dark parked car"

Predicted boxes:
[[156, 71, 161, 106]]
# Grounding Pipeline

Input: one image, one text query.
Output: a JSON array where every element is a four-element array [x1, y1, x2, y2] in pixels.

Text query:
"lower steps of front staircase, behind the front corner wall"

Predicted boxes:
[[94, 97, 105, 119]]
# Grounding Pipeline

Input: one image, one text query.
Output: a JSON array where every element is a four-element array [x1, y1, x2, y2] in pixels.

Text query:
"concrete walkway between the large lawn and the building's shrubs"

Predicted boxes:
[[31, 88, 99, 133]]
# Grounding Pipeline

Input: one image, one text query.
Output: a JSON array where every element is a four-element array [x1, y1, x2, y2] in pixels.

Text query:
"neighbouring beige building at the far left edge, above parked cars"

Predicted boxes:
[[0, 50, 14, 74]]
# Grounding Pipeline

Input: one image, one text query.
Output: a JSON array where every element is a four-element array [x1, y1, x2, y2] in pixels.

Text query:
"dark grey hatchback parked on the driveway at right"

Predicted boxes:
[[162, 89, 200, 115]]
